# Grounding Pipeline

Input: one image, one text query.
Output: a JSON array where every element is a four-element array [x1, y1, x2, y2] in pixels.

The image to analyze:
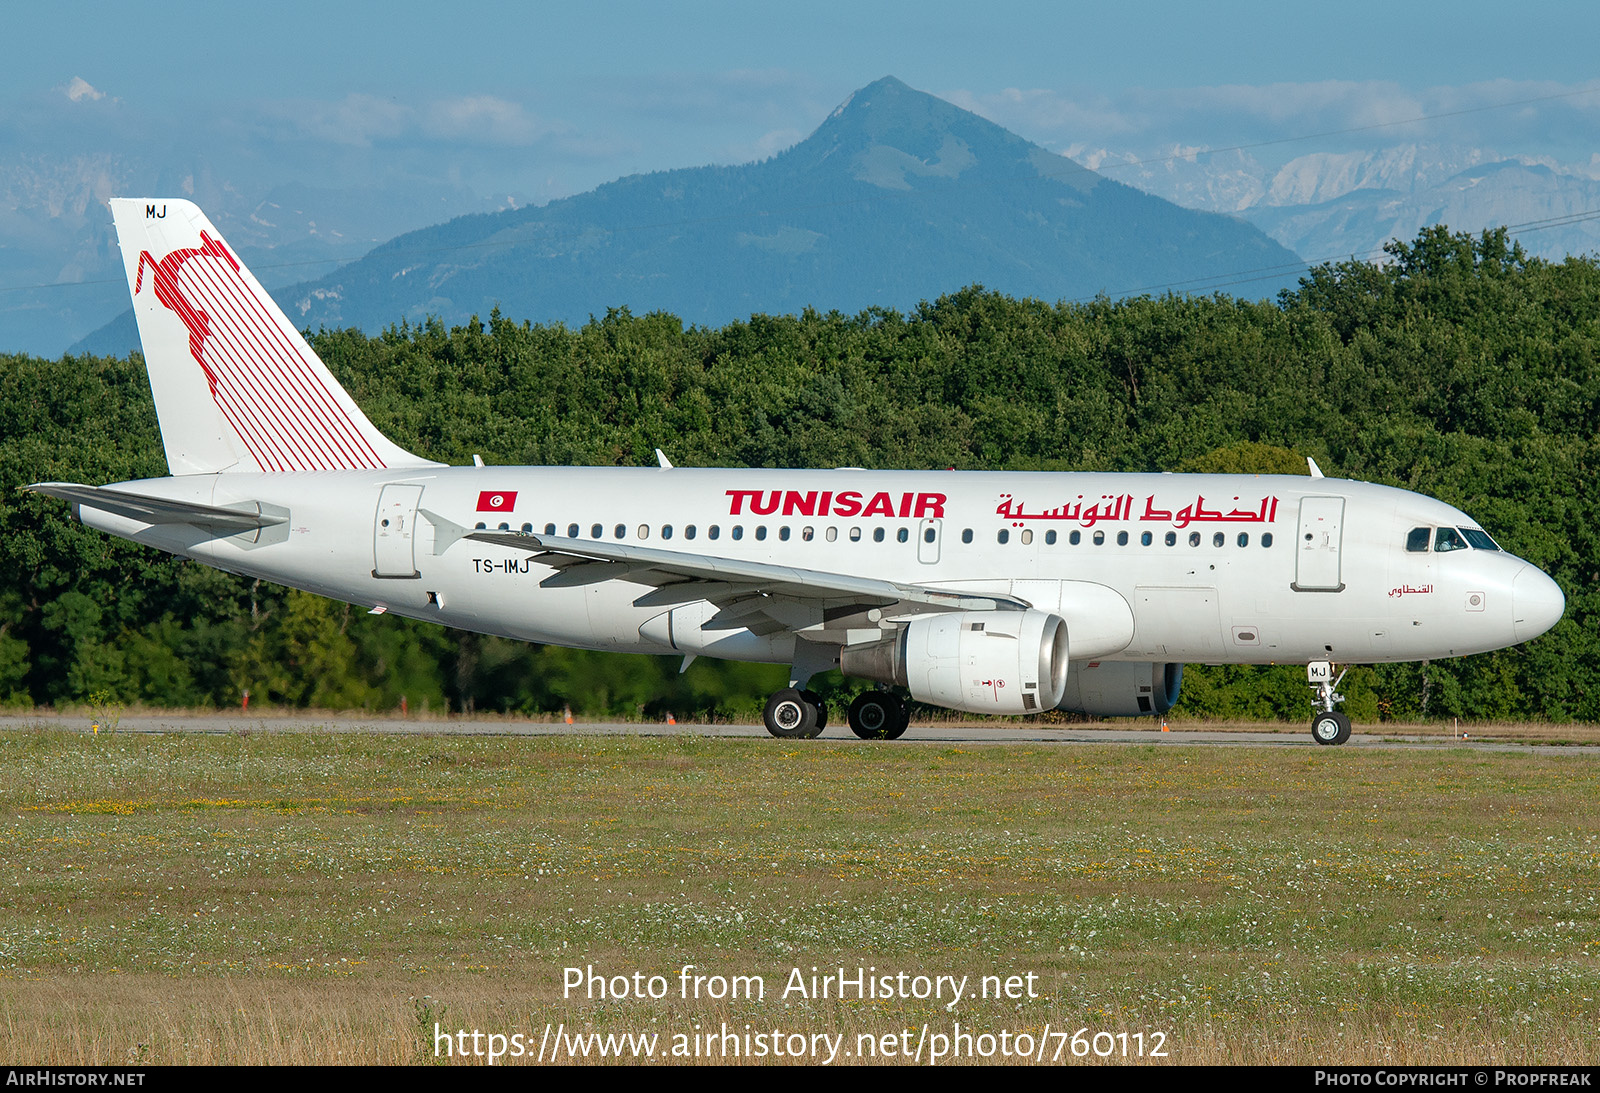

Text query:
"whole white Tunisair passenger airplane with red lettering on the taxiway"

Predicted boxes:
[[26, 198, 1565, 744]]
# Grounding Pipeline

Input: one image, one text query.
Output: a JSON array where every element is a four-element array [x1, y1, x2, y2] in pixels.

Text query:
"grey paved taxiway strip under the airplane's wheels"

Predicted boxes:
[[0, 714, 1600, 759]]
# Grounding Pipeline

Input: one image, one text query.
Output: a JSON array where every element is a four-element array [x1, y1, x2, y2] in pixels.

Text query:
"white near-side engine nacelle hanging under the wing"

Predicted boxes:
[[838, 610, 1067, 714]]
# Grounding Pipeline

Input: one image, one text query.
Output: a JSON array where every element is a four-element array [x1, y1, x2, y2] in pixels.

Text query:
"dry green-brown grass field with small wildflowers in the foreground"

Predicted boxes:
[[0, 728, 1600, 1064]]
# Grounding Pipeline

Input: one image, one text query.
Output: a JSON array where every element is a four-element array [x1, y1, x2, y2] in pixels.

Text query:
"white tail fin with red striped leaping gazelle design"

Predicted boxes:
[[110, 198, 440, 475]]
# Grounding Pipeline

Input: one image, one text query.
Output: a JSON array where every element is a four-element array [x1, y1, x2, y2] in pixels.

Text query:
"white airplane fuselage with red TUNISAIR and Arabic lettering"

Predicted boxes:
[[82, 467, 1562, 664]]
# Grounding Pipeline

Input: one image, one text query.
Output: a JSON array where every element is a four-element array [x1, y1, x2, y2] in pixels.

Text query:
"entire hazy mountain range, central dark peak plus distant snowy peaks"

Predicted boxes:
[[12, 78, 1600, 355]]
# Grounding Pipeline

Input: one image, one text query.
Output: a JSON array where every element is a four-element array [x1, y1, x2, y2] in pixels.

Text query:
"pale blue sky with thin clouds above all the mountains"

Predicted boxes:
[[15, 0, 1600, 200]]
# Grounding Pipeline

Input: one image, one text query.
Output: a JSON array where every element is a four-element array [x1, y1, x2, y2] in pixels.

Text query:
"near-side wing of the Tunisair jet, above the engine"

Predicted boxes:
[[438, 521, 1029, 640]]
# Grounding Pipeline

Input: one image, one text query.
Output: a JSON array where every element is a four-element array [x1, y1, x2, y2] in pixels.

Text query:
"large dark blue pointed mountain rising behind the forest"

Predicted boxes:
[[83, 78, 1298, 358]]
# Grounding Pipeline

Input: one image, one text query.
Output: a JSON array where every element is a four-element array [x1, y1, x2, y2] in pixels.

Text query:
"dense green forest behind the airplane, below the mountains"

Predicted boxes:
[[0, 227, 1600, 722]]
